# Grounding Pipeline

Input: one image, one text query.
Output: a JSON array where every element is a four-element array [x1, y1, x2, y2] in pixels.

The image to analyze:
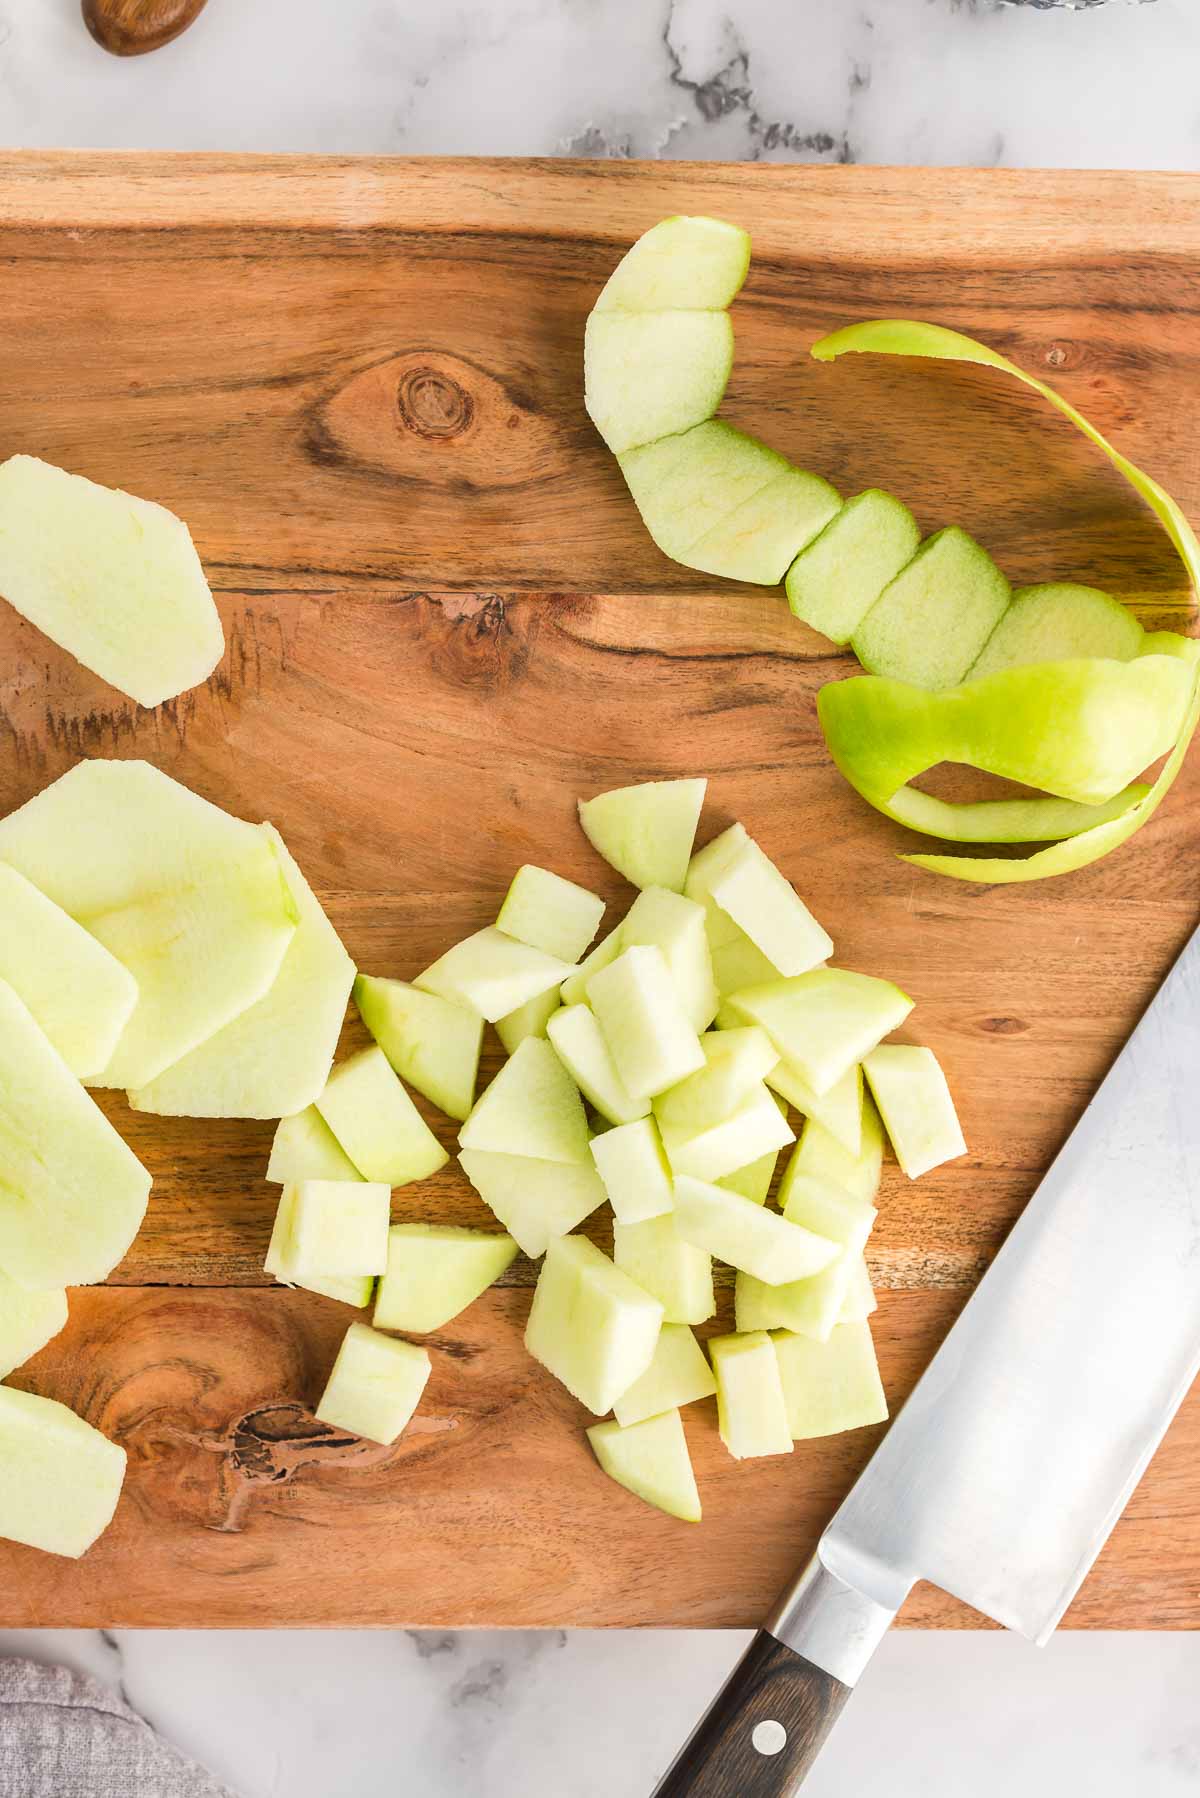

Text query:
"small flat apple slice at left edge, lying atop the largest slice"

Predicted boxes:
[[0, 863, 137, 1081]]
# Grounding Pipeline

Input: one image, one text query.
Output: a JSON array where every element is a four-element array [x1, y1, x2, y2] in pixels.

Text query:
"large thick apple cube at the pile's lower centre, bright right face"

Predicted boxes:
[[525, 1235, 662, 1417]]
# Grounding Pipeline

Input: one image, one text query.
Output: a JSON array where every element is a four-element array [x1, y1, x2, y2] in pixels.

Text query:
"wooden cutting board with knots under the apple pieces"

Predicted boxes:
[[0, 156, 1200, 1627]]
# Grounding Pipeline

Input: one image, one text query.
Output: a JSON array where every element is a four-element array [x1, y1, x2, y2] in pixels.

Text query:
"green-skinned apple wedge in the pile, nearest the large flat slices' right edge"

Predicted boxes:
[[354, 975, 482, 1124]]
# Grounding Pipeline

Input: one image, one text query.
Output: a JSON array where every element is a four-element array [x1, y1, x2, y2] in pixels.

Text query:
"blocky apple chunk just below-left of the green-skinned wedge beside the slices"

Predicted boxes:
[[317, 1046, 450, 1186]]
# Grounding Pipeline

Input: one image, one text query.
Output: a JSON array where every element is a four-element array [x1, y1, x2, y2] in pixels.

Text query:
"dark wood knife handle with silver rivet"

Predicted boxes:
[[655, 1629, 851, 1798]]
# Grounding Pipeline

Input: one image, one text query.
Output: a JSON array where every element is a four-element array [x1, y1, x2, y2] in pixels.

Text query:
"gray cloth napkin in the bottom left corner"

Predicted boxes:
[[0, 1660, 236, 1798]]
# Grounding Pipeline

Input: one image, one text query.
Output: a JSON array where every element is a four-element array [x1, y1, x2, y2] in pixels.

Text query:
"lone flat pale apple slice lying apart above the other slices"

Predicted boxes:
[[0, 455, 225, 707]]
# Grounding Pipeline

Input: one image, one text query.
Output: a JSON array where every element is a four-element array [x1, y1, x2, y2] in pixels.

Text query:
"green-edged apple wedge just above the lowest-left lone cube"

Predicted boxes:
[[372, 1224, 516, 1332]]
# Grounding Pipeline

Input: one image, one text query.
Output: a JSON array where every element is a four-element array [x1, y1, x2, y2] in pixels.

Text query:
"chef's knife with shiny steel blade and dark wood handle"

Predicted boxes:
[[655, 931, 1200, 1798]]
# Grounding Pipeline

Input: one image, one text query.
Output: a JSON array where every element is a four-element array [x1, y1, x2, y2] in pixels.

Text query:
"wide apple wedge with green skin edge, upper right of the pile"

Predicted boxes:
[[729, 967, 912, 1095]]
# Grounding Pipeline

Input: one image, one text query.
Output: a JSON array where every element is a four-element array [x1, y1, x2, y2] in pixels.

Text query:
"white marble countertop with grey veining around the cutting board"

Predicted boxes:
[[0, 0, 1200, 1798]]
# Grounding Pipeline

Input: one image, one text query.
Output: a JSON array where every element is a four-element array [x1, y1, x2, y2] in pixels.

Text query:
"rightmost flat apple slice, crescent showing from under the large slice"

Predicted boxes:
[[130, 823, 354, 1118]]
